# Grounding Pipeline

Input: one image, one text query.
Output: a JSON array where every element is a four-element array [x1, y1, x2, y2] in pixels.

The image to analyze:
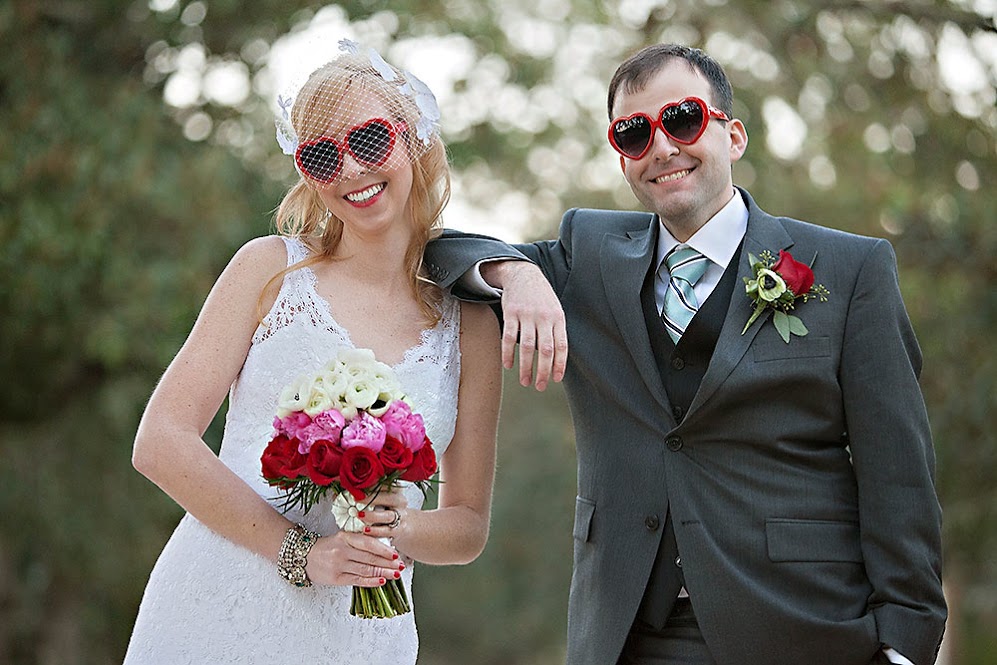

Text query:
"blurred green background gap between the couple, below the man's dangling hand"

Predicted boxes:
[[414, 370, 575, 665]]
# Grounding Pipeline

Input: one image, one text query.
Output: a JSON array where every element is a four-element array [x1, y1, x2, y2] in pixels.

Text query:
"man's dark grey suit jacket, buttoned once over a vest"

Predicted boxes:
[[427, 190, 946, 665]]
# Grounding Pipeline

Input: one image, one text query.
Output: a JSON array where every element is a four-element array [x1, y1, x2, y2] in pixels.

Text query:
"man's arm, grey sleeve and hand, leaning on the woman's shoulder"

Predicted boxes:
[[425, 211, 573, 390]]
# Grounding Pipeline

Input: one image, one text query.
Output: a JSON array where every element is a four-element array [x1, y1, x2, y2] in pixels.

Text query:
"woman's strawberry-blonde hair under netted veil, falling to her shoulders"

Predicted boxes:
[[259, 54, 450, 325]]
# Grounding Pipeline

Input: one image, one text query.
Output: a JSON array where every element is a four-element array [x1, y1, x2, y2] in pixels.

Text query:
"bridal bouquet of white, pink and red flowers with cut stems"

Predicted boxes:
[[260, 349, 437, 618]]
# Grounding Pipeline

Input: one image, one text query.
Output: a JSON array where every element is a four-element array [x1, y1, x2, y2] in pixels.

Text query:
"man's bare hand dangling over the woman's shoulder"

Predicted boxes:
[[481, 261, 568, 390]]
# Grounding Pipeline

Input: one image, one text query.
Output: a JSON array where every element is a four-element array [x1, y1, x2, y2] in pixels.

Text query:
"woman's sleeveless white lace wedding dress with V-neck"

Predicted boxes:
[[125, 239, 460, 665]]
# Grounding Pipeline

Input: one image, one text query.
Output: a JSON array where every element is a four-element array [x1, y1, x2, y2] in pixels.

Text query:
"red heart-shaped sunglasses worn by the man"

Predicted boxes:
[[609, 97, 730, 159]]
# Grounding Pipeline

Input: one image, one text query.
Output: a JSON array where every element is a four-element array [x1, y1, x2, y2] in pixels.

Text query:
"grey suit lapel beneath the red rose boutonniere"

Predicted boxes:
[[687, 191, 793, 419]]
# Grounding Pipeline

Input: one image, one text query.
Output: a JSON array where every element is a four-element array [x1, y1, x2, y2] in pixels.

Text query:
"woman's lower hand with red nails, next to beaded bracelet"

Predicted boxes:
[[305, 531, 405, 587]]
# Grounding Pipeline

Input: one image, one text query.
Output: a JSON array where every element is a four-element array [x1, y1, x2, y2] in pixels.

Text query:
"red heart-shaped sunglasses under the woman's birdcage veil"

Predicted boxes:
[[294, 118, 404, 183]]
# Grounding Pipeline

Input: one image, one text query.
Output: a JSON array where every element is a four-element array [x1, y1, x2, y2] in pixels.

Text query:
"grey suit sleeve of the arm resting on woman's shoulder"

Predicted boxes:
[[425, 209, 575, 301]]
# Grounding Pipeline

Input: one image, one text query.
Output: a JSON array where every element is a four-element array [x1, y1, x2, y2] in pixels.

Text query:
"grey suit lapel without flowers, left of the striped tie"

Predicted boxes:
[[599, 220, 671, 413]]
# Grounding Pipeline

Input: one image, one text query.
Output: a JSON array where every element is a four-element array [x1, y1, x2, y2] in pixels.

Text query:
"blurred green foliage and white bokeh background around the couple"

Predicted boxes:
[[0, 0, 997, 665]]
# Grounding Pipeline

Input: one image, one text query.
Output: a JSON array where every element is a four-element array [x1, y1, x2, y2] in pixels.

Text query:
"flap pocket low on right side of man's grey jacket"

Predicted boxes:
[[765, 518, 863, 563]]
